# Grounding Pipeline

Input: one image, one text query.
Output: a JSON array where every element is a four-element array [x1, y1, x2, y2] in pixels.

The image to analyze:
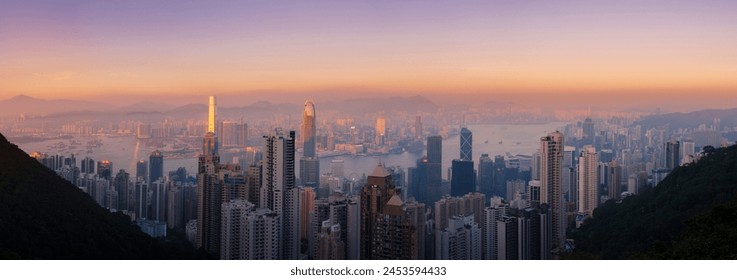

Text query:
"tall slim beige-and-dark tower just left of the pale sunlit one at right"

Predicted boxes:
[[540, 131, 566, 251]]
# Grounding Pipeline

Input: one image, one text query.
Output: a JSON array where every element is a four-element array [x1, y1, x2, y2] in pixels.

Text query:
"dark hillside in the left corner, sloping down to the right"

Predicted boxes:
[[0, 135, 209, 259]]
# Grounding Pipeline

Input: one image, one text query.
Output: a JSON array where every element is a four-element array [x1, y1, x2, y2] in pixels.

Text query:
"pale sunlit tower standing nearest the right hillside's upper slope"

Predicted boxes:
[[578, 146, 599, 217]]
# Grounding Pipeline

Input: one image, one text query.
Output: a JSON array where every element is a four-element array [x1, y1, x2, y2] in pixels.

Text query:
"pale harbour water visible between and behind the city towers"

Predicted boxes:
[[19, 122, 566, 179]]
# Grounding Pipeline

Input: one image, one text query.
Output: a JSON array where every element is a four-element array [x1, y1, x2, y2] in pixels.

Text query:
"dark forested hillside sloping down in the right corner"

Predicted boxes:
[[568, 143, 737, 259]]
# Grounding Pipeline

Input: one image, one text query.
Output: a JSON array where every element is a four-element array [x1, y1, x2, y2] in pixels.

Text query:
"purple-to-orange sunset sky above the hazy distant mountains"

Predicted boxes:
[[0, 0, 737, 103]]
